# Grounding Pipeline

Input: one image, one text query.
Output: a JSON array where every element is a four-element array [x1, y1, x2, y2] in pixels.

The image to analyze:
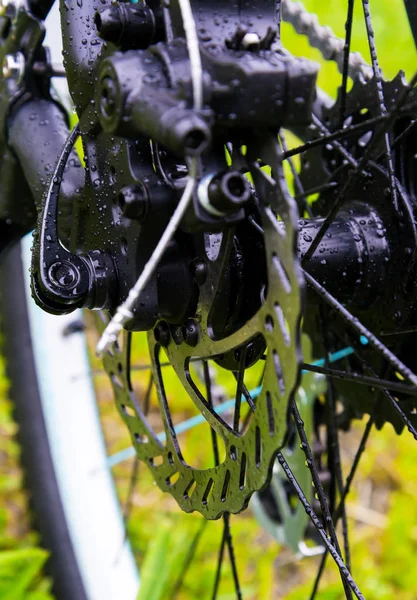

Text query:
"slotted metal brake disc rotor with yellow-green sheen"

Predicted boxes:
[[99, 134, 303, 519]]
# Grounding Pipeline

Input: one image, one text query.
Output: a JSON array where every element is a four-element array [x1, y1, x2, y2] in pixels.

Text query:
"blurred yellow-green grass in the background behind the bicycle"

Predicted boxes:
[[0, 0, 417, 600]]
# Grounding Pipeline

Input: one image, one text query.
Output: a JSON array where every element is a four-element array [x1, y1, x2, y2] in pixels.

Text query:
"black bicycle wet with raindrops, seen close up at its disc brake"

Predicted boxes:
[[0, 0, 417, 600]]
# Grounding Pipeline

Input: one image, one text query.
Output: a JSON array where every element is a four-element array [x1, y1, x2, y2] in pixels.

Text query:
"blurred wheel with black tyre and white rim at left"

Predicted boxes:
[[0, 237, 139, 600]]
